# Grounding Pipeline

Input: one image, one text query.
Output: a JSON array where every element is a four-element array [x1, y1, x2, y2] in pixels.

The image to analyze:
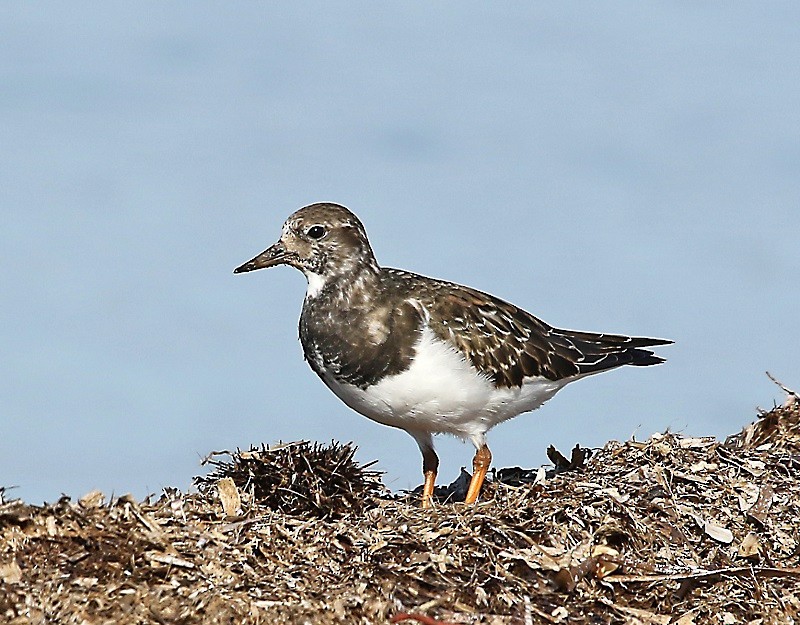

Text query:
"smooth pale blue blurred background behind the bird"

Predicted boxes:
[[0, 1, 800, 502]]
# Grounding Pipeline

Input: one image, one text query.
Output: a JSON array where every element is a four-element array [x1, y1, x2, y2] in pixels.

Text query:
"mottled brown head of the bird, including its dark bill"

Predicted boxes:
[[234, 203, 378, 285]]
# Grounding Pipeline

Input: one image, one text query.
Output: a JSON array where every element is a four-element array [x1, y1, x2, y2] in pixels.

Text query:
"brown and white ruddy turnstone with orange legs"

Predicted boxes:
[[234, 203, 672, 507]]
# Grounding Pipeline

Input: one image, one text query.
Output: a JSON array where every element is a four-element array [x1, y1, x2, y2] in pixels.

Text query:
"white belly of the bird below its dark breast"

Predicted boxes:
[[318, 328, 574, 442]]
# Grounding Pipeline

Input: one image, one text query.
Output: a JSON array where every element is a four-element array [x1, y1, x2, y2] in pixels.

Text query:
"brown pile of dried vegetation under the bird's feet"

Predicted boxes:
[[0, 382, 800, 625]]
